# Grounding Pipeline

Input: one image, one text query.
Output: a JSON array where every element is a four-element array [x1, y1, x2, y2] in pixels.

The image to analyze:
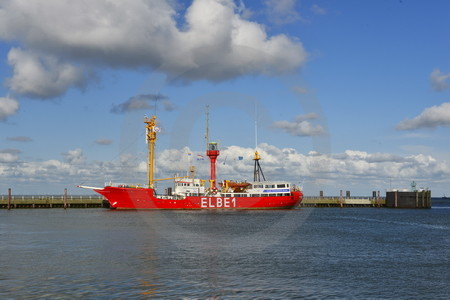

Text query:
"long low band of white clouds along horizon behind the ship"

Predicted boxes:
[[0, 144, 450, 195]]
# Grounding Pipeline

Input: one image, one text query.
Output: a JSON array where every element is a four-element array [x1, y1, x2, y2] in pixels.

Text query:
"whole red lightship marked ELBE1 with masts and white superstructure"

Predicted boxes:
[[79, 116, 303, 209]]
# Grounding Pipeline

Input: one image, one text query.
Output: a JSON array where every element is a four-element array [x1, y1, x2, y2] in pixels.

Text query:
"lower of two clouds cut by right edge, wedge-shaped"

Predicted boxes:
[[396, 102, 450, 130]]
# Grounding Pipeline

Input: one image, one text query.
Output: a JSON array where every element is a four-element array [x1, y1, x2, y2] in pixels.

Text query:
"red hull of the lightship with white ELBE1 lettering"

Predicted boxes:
[[95, 186, 303, 209]]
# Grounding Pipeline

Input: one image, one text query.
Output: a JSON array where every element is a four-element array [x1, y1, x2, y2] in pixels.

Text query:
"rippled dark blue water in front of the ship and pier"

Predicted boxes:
[[0, 205, 450, 299]]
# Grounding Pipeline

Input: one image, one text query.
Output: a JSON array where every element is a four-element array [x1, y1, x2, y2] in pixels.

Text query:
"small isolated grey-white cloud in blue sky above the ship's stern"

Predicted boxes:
[[273, 113, 325, 136]]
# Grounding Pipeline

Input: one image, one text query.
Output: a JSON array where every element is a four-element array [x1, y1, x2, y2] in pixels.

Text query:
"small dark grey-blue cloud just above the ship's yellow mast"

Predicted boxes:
[[111, 94, 174, 114]]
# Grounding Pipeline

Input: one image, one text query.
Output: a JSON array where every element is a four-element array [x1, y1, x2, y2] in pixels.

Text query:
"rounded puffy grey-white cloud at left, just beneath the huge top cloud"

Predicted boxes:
[[7, 48, 86, 99]]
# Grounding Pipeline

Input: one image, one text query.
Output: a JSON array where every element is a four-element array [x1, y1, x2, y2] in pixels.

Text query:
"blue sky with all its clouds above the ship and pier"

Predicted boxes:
[[0, 0, 450, 197]]
